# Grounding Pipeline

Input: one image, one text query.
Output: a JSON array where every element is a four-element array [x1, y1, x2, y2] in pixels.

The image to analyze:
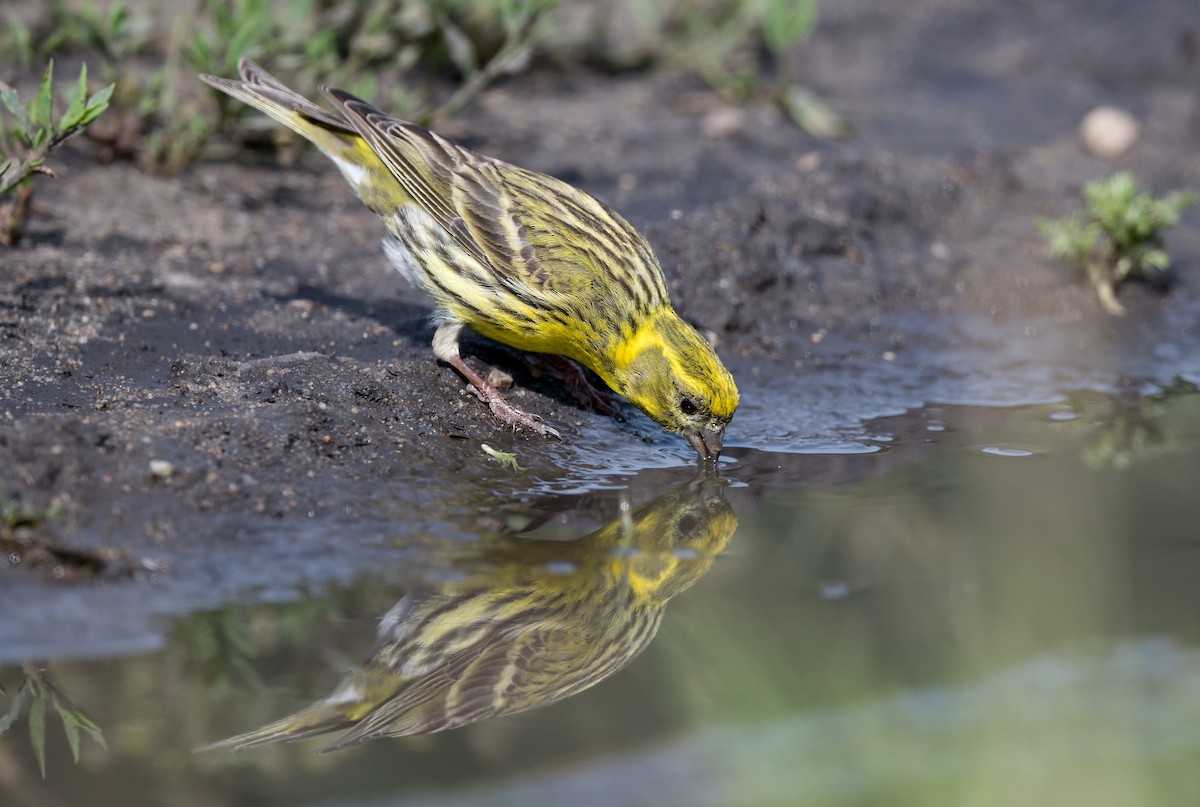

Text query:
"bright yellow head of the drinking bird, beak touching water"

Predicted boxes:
[[614, 309, 738, 464]]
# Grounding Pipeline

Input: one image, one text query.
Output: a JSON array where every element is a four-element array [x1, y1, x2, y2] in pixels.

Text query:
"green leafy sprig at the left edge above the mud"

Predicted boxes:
[[0, 61, 113, 246]]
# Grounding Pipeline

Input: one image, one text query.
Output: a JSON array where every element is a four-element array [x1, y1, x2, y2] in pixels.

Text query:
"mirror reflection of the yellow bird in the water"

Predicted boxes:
[[202, 480, 737, 751]]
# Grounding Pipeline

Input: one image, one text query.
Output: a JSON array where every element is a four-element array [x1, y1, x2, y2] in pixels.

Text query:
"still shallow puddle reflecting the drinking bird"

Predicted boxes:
[[0, 389, 1200, 807]]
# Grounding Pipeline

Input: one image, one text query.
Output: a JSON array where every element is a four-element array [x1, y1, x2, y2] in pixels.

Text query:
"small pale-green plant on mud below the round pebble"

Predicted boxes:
[[1037, 172, 1200, 316]]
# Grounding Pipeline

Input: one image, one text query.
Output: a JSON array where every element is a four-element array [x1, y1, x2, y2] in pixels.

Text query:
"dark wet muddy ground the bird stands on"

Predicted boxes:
[[0, 0, 1200, 660]]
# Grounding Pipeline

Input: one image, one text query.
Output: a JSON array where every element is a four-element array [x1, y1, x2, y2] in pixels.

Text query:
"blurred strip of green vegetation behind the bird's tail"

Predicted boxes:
[[0, 0, 840, 174]]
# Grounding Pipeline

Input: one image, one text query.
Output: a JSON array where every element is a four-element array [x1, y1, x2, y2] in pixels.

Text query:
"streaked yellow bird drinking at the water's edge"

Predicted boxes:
[[200, 59, 738, 464]]
